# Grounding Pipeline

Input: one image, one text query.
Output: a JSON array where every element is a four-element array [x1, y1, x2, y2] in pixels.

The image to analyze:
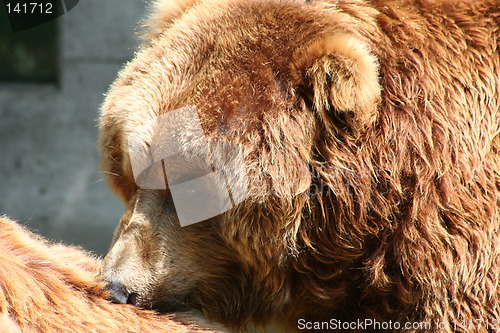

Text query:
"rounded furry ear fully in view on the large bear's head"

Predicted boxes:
[[292, 33, 381, 127]]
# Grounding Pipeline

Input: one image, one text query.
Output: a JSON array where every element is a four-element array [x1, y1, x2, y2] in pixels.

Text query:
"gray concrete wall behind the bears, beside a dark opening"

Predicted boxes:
[[0, 0, 145, 254]]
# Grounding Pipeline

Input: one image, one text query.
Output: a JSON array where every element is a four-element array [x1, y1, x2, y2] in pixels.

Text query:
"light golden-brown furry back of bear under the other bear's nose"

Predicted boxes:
[[0, 217, 222, 333]]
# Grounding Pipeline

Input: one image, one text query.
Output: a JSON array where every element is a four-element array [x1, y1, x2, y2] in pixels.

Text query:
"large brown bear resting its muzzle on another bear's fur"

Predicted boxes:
[[100, 0, 500, 332]]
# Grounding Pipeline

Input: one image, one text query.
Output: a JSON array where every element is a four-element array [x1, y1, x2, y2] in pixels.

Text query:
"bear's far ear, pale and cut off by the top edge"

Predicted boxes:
[[142, 0, 199, 40]]
